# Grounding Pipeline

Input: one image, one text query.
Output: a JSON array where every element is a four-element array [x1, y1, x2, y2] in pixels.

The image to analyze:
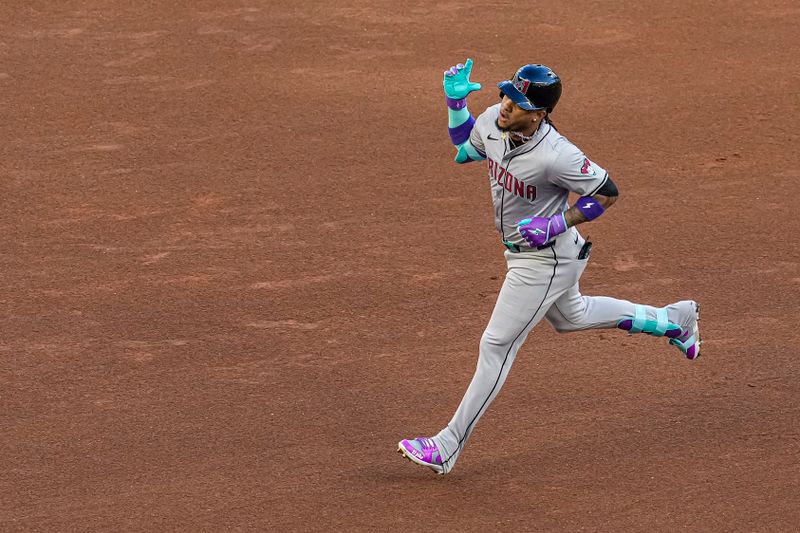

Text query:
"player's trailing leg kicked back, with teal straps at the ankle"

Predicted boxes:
[[546, 283, 700, 359]]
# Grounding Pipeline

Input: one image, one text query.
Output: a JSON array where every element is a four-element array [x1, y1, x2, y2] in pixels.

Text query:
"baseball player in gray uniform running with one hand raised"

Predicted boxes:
[[398, 59, 700, 474]]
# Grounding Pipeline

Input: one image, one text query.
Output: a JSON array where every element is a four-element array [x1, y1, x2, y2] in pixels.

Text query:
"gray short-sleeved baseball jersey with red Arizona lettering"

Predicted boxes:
[[470, 104, 608, 246]]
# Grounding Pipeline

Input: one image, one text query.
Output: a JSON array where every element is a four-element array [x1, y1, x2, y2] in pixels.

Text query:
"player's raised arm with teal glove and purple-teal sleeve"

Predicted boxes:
[[442, 59, 486, 163]]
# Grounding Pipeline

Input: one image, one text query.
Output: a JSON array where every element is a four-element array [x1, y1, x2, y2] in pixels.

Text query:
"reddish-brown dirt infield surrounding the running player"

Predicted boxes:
[[0, 0, 800, 532]]
